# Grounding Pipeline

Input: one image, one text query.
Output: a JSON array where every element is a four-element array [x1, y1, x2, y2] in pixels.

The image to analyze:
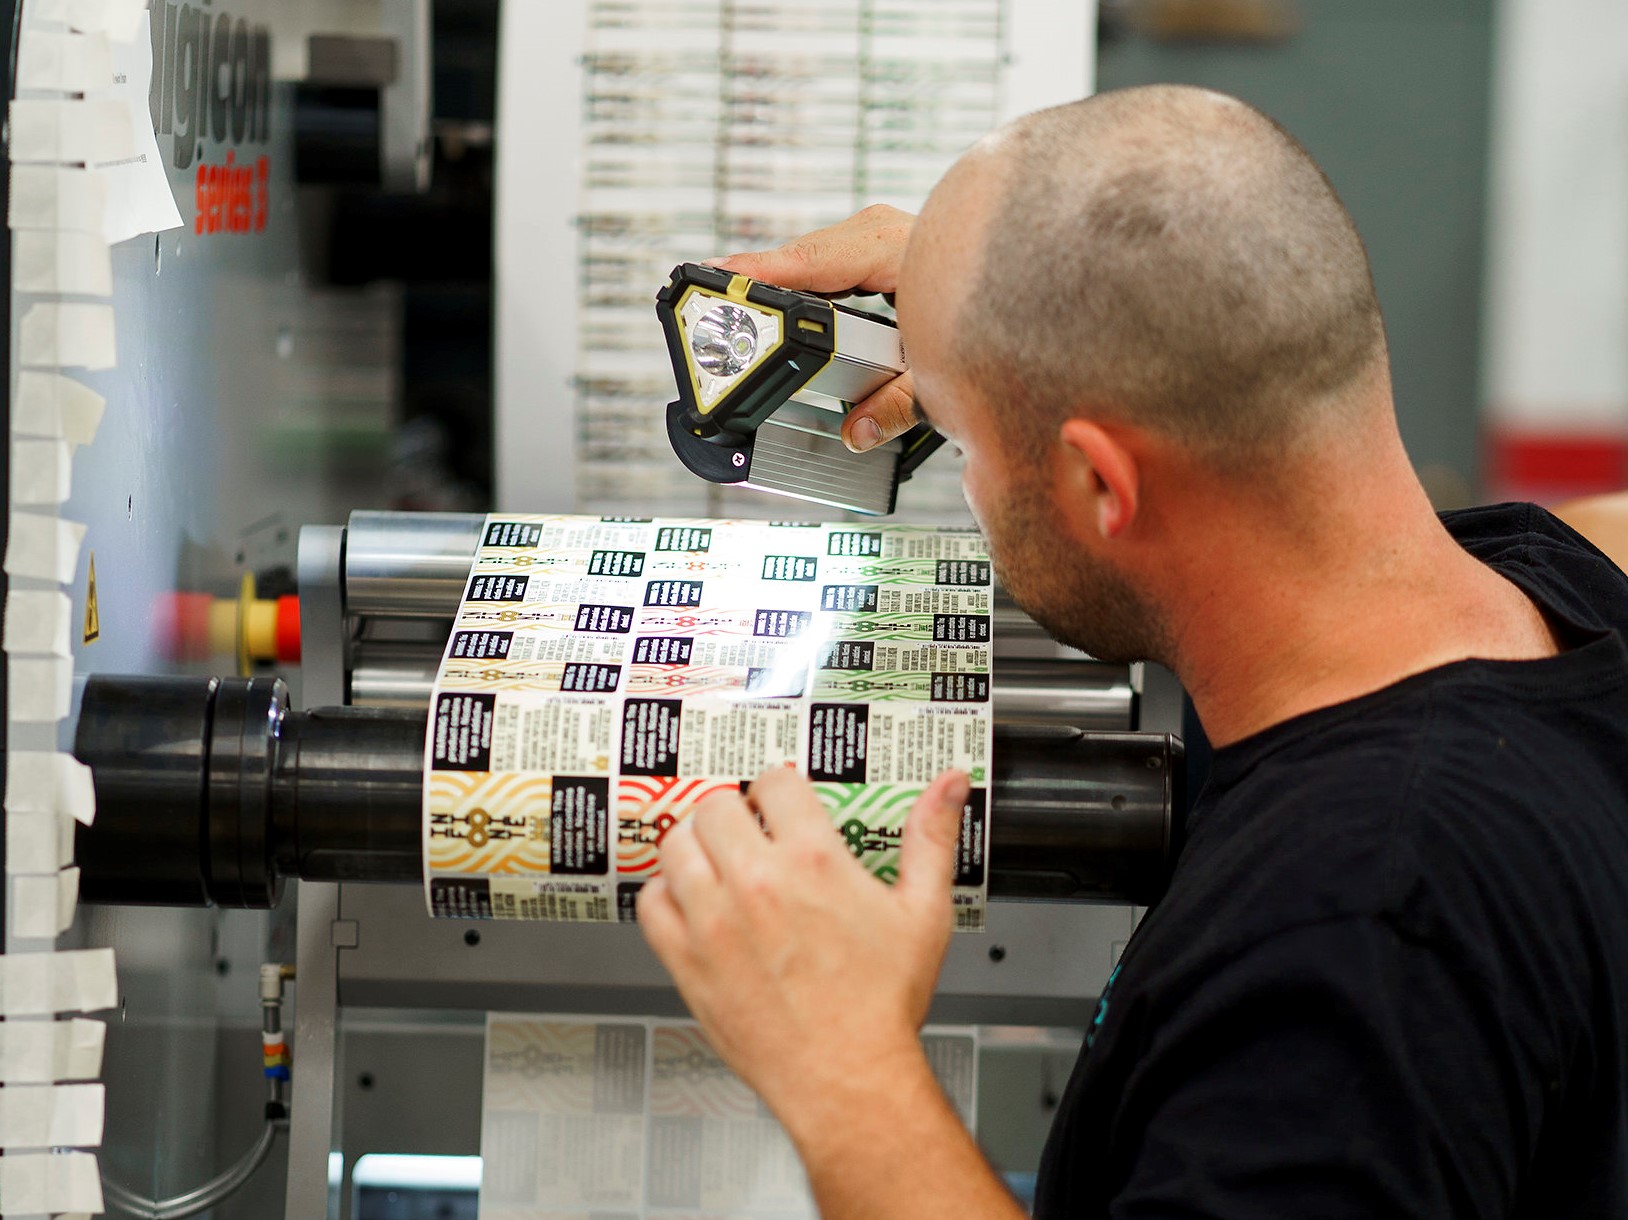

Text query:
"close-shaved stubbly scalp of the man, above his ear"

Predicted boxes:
[[944, 86, 1385, 463]]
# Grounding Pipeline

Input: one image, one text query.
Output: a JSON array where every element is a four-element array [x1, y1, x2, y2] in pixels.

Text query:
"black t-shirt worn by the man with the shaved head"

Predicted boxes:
[[1035, 505, 1628, 1220]]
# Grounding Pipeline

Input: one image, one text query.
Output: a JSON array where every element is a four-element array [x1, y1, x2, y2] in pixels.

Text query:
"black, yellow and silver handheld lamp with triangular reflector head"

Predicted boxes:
[[656, 262, 944, 515]]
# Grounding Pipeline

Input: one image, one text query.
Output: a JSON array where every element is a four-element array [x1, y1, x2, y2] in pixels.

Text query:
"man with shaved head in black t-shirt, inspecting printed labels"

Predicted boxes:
[[640, 88, 1628, 1220]]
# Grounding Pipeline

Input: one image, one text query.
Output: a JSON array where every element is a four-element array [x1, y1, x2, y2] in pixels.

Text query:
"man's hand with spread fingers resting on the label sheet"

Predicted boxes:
[[638, 767, 967, 1143]]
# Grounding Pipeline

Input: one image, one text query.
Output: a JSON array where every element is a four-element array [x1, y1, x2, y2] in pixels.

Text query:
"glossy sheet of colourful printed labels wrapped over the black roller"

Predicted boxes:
[[423, 513, 993, 930]]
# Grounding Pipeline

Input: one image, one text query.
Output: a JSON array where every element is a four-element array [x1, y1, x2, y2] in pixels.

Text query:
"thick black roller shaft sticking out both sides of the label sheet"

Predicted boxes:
[[75, 676, 1184, 907]]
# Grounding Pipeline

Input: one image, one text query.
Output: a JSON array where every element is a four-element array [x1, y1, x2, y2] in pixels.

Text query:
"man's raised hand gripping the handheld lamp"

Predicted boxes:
[[708, 204, 917, 453]]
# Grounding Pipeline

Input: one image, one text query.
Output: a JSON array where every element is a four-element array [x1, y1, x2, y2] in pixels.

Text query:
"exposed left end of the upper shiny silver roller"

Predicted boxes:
[[345, 511, 485, 619]]
